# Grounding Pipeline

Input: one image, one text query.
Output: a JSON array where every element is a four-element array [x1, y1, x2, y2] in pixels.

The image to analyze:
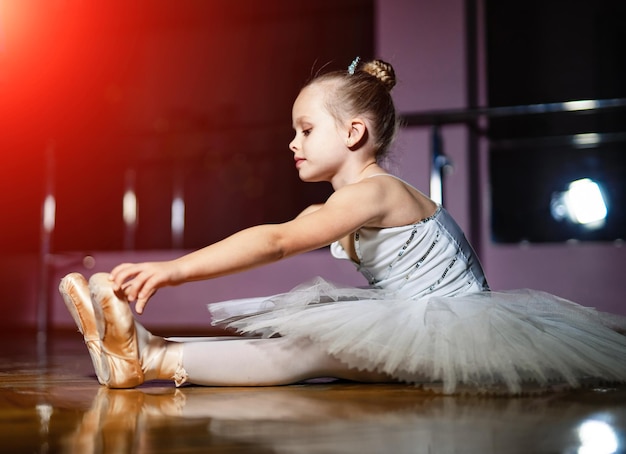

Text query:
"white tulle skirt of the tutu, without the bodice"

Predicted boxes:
[[209, 278, 626, 394]]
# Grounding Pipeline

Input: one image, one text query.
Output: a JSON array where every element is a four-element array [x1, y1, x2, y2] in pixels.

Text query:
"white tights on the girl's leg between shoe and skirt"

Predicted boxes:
[[176, 337, 391, 386]]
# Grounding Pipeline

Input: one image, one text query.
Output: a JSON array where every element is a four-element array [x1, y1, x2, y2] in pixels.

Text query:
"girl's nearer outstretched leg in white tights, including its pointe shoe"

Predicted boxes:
[[89, 273, 390, 388]]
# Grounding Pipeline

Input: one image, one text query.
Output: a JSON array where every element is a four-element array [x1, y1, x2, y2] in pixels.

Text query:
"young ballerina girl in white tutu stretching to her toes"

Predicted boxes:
[[60, 59, 626, 394]]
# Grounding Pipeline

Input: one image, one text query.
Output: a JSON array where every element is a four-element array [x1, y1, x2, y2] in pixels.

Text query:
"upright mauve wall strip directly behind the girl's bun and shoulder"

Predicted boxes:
[[376, 0, 469, 228]]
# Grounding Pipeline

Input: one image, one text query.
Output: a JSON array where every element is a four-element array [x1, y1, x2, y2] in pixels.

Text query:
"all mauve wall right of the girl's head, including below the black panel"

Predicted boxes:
[[376, 0, 626, 314]]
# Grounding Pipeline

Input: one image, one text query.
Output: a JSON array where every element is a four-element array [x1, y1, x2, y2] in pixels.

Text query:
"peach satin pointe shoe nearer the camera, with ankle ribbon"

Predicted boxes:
[[89, 273, 187, 388]]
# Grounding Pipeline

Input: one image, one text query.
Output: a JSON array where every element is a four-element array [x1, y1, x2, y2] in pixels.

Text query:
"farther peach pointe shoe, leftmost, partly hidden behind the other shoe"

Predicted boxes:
[[59, 273, 104, 384]]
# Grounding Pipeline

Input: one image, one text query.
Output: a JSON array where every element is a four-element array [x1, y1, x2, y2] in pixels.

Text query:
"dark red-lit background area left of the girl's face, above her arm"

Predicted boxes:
[[0, 0, 374, 253]]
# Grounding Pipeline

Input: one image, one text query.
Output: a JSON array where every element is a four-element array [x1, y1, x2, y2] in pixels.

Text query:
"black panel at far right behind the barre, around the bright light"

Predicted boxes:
[[486, 0, 626, 242]]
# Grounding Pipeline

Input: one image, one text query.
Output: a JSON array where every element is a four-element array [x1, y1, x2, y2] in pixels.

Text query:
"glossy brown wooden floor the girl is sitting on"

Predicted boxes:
[[0, 332, 626, 454]]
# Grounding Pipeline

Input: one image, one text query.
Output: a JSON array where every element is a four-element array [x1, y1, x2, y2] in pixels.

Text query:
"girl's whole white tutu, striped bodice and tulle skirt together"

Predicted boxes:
[[209, 202, 626, 394]]
